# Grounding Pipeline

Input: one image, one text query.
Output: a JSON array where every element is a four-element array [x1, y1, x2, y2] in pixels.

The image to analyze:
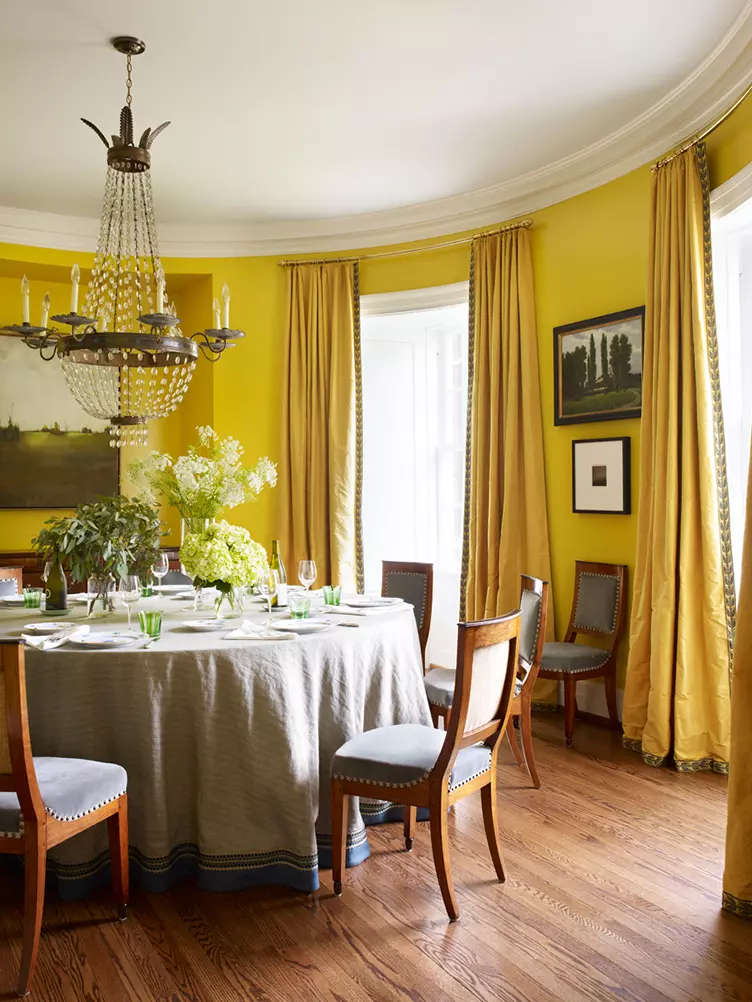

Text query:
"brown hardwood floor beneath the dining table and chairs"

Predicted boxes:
[[0, 717, 752, 1002]]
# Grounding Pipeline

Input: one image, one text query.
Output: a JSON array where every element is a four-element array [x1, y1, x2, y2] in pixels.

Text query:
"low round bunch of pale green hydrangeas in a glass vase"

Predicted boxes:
[[180, 521, 269, 616]]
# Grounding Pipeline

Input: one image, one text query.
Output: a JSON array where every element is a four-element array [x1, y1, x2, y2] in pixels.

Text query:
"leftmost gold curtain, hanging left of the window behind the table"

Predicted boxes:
[[280, 262, 363, 591]]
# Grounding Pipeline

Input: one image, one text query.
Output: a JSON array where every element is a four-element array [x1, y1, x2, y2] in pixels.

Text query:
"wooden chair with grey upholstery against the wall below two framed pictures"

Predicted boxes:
[[538, 560, 627, 744]]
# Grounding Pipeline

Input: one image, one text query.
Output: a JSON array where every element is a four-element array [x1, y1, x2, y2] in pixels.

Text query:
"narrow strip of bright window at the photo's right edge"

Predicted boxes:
[[711, 171, 752, 588]]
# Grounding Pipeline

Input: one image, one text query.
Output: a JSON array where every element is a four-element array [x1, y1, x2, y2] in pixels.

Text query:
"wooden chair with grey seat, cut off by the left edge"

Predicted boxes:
[[0, 639, 128, 995]]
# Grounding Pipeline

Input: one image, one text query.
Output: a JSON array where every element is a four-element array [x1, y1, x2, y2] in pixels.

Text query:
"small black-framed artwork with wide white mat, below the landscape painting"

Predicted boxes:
[[572, 437, 632, 515]]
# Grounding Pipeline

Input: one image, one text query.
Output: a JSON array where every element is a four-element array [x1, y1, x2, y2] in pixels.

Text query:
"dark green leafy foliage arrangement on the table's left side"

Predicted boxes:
[[31, 495, 165, 581]]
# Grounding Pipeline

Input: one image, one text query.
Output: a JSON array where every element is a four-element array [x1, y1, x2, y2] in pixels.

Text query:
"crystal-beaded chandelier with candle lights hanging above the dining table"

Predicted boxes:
[[0, 36, 244, 448]]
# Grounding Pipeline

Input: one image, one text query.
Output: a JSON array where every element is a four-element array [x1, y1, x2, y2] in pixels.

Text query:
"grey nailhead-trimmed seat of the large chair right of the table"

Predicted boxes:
[[332, 723, 491, 790]]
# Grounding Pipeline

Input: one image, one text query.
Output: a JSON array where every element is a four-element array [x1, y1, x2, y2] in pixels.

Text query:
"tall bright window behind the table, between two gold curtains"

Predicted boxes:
[[361, 283, 467, 666]]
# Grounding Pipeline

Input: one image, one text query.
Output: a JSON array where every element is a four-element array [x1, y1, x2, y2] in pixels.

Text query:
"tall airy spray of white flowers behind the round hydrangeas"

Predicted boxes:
[[127, 426, 277, 519]]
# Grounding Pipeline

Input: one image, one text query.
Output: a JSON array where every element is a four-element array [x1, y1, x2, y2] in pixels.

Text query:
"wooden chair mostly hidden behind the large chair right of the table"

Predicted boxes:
[[424, 574, 548, 790]]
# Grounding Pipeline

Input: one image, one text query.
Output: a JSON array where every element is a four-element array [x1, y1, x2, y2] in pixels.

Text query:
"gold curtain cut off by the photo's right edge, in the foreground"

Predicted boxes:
[[723, 444, 752, 919]]
